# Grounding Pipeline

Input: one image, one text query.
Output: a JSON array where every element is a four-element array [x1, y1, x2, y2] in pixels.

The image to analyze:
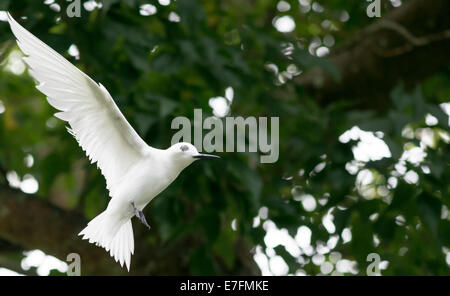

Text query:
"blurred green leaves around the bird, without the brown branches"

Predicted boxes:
[[0, 0, 450, 275]]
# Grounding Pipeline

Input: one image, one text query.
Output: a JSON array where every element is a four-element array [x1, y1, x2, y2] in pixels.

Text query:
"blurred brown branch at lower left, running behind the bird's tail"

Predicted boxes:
[[0, 187, 126, 275]]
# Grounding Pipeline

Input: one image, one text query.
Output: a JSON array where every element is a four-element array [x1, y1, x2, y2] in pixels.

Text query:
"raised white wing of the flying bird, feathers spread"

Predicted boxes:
[[8, 13, 154, 196]]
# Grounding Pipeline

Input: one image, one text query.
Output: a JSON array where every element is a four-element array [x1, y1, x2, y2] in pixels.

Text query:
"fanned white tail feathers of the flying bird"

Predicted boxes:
[[78, 211, 134, 271]]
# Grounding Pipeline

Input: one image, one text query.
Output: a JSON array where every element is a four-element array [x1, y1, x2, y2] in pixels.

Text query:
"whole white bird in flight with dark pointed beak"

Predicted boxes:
[[8, 13, 218, 271]]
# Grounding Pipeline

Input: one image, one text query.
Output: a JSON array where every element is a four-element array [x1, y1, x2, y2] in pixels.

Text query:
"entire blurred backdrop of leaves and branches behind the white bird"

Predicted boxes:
[[0, 0, 450, 275]]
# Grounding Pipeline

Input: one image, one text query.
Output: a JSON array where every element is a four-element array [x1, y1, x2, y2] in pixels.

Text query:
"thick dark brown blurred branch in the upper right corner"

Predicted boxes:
[[295, 0, 450, 109]]
